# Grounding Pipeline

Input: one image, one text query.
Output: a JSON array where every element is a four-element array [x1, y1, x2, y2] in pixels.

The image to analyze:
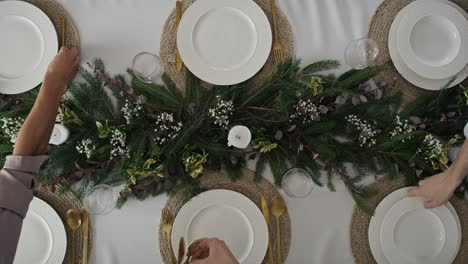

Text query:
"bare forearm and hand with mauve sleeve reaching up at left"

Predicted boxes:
[[0, 49, 79, 264]]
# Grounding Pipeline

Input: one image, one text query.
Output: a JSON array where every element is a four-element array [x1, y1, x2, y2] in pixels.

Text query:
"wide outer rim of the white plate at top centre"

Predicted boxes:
[[177, 0, 272, 85]]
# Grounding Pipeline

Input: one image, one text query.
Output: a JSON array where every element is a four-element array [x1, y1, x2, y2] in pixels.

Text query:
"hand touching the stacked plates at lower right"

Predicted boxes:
[[409, 169, 460, 208]]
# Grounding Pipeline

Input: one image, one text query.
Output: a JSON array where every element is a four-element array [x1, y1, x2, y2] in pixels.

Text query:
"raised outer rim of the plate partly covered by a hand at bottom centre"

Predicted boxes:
[[172, 189, 268, 264]]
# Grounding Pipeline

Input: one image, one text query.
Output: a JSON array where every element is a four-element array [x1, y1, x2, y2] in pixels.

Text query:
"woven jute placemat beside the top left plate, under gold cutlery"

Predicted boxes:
[[23, 0, 81, 48]]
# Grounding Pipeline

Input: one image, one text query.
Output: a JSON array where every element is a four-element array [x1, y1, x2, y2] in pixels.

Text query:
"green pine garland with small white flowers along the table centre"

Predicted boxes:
[[0, 59, 468, 212]]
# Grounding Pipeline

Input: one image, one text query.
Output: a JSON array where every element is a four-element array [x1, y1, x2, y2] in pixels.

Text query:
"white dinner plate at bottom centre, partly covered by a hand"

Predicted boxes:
[[172, 190, 268, 264]]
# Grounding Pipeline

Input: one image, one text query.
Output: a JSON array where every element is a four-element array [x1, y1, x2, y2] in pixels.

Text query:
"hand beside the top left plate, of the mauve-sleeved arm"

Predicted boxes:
[[44, 47, 80, 94]]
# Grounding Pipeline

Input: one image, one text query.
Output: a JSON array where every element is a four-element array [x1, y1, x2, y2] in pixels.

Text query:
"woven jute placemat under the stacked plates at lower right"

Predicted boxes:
[[349, 177, 468, 264]]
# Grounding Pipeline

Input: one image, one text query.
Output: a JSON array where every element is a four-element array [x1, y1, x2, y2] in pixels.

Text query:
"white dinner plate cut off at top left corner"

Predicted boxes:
[[0, 1, 58, 94]]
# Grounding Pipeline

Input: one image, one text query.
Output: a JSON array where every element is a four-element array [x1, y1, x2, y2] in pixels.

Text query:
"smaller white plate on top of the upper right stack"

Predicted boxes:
[[398, 0, 468, 79]]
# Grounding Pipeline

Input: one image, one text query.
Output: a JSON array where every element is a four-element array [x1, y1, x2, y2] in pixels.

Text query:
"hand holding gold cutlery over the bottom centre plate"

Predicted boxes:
[[190, 238, 239, 264]]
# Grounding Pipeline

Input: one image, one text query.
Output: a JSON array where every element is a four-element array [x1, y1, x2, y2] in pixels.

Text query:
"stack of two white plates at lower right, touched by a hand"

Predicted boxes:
[[369, 188, 461, 264]]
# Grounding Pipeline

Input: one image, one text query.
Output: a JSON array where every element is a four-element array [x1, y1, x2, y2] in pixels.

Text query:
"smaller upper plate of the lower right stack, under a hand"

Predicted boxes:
[[380, 197, 459, 264]]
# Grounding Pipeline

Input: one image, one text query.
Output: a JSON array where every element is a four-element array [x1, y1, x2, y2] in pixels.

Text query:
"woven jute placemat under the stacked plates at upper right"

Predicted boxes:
[[369, 0, 468, 103]]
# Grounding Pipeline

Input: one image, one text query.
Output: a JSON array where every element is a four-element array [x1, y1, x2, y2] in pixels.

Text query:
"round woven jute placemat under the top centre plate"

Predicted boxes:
[[159, 0, 294, 93]]
